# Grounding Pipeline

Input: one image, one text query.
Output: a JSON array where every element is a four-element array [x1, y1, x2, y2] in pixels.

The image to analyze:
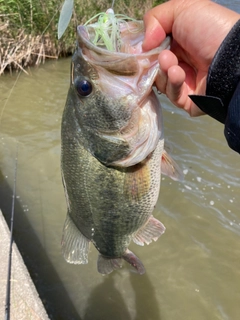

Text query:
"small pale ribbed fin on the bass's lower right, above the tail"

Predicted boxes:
[[133, 216, 166, 246]]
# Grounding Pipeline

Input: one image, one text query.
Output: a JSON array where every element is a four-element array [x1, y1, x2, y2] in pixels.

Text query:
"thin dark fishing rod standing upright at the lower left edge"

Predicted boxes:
[[5, 142, 18, 320]]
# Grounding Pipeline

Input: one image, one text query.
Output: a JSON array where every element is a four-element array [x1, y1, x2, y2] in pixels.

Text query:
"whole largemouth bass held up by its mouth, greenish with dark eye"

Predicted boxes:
[[61, 12, 179, 274]]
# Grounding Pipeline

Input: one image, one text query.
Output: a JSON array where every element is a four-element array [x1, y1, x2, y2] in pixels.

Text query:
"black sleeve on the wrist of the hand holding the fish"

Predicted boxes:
[[189, 20, 240, 153]]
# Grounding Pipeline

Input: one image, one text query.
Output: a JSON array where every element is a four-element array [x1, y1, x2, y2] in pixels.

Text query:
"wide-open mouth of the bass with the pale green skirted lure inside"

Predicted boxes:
[[77, 9, 170, 76]]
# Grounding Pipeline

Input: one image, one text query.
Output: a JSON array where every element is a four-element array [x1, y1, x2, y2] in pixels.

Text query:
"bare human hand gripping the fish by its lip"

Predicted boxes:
[[143, 0, 240, 116]]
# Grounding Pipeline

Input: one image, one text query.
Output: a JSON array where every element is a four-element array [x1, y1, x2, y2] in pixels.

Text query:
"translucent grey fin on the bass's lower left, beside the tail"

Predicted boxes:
[[62, 214, 89, 264]]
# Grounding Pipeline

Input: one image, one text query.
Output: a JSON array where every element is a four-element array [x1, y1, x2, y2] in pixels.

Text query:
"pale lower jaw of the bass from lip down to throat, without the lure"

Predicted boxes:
[[77, 21, 171, 106]]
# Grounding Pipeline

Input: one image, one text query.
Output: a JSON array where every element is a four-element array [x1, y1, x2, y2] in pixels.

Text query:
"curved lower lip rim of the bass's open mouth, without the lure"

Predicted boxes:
[[77, 21, 170, 76]]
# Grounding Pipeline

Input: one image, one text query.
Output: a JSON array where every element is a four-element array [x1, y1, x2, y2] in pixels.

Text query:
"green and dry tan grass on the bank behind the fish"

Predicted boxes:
[[0, 0, 164, 75]]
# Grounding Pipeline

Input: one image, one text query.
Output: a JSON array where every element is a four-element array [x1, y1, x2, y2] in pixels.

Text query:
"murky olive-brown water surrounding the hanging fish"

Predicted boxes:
[[0, 1, 240, 320]]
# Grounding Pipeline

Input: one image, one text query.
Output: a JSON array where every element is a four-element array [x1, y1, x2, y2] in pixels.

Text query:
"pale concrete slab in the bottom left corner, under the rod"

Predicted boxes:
[[0, 211, 49, 320]]
